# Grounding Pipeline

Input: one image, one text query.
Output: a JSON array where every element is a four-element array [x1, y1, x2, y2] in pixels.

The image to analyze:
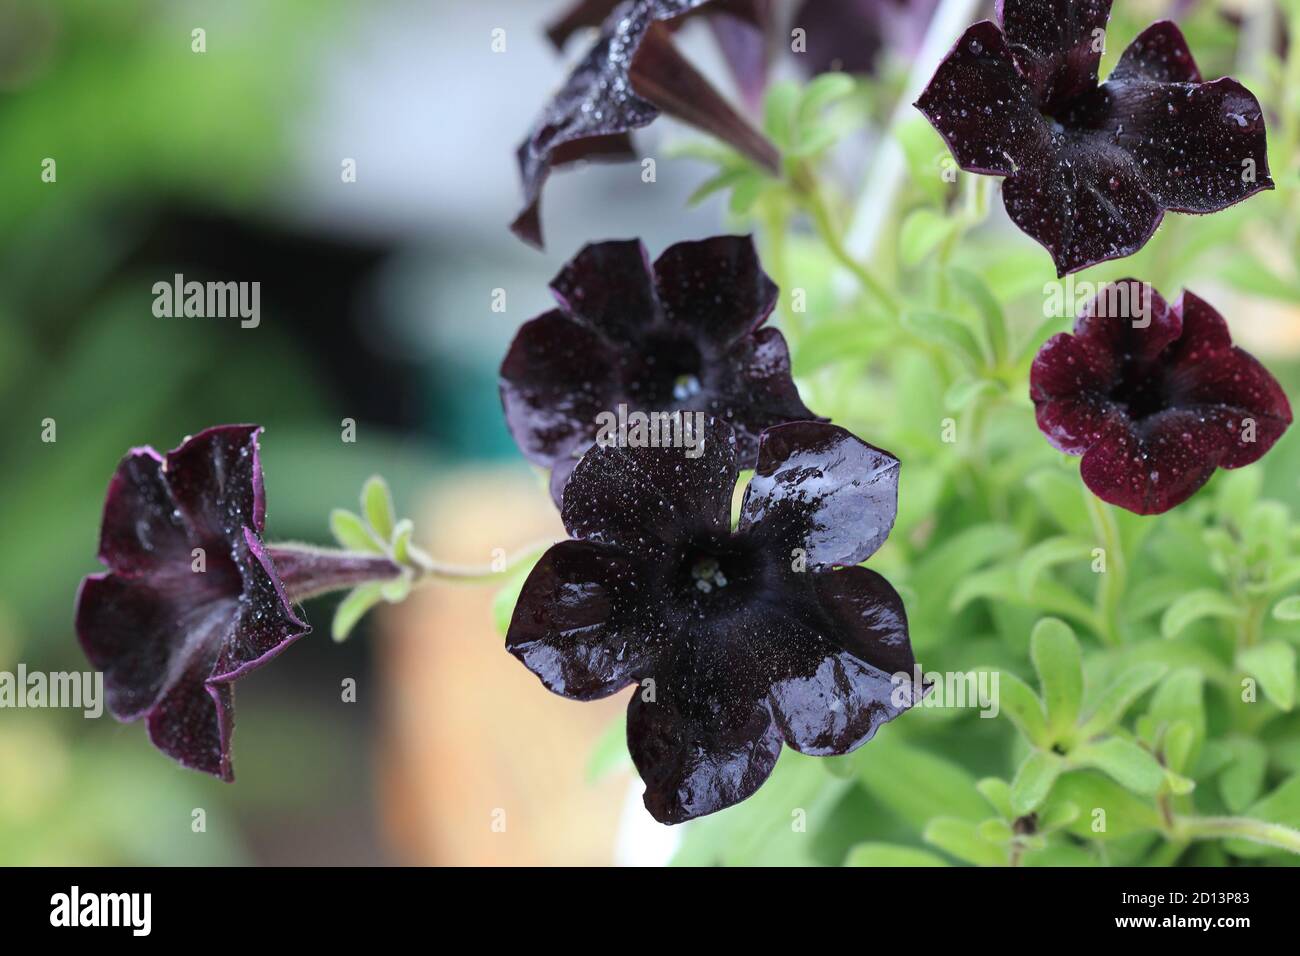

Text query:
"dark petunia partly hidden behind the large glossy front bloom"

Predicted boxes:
[[501, 235, 818, 503]]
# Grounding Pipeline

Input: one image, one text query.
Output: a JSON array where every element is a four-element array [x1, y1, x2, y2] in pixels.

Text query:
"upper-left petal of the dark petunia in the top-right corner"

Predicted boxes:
[[915, 20, 1052, 176]]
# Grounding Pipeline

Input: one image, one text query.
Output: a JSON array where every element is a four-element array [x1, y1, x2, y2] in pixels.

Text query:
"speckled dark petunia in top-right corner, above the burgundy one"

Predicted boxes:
[[917, 0, 1273, 276]]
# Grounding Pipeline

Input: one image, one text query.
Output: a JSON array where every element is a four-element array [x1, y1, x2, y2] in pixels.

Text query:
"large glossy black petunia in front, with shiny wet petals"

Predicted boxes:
[[506, 419, 915, 823]]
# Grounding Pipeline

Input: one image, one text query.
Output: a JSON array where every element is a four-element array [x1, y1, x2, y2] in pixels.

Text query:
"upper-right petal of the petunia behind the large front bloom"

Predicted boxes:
[[654, 235, 776, 349]]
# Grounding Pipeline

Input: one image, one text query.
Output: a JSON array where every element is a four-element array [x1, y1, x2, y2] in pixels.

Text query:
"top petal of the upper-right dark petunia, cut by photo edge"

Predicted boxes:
[[996, 0, 1110, 114]]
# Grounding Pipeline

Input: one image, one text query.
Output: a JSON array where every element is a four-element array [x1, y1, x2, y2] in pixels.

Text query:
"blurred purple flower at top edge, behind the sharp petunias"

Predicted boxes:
[[793, 0, 937, 75]]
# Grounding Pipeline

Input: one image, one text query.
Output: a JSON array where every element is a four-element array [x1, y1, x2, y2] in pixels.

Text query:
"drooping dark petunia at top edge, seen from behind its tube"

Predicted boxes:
[[511, 0, 779, 246]]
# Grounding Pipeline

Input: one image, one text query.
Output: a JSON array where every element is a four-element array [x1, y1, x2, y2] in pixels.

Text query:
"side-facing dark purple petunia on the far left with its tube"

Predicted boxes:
[[75, 425, 400, 780]]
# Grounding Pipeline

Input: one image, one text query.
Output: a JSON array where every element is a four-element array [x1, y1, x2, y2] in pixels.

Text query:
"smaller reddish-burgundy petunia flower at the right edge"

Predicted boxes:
[[1030, 280, 1291, 515]]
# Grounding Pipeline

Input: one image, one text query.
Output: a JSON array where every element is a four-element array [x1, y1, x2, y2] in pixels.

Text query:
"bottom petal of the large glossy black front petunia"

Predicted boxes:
[[628, 671, 781, 823]]
